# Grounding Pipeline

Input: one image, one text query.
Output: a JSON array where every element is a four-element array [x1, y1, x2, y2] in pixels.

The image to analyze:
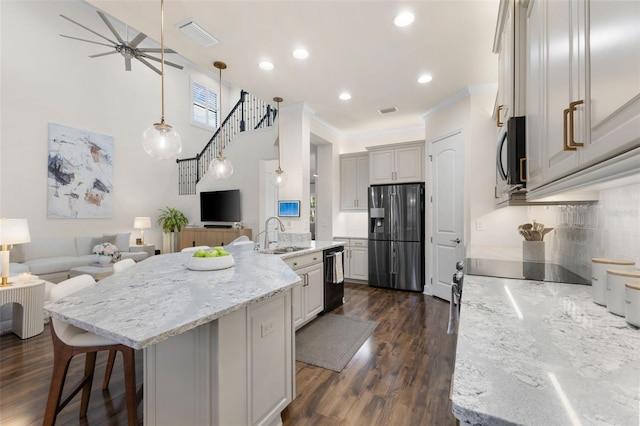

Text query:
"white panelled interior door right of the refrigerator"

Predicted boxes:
[[429, 131, 464, 300]]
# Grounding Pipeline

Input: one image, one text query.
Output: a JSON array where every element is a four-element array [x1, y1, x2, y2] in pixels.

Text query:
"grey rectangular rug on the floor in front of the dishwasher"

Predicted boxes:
[[296, 314, 378, 373]]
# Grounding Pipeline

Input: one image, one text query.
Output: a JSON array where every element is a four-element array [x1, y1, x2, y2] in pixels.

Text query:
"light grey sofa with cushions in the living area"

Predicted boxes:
[[10, 233, 148, 283]]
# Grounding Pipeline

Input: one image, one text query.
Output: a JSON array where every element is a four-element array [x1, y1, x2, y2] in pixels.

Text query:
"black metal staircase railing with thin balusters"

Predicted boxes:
[[176, 90, 277, 195]]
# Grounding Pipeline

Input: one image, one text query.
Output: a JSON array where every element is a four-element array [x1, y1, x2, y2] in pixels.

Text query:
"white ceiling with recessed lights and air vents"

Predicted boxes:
[[87, 0, 499, 136]]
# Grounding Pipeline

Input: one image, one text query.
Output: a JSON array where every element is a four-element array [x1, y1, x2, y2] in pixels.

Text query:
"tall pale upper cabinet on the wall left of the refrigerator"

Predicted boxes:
[[340, 152, 369, 210]]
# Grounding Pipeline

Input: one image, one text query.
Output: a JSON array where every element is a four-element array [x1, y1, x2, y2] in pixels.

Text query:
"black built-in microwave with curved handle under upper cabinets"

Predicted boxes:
[[496, 117, 527, 186]]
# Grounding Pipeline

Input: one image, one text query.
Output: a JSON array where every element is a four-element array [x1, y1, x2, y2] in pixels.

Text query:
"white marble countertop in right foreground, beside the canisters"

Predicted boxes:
[[452, 275, 640, 426]]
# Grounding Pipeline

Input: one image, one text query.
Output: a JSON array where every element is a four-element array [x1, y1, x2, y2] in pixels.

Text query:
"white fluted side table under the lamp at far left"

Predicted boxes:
[[0, 277, 45, 339]]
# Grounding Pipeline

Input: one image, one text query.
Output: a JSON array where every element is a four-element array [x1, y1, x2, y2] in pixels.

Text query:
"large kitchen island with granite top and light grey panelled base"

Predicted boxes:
[[45, 247, 300, 425]]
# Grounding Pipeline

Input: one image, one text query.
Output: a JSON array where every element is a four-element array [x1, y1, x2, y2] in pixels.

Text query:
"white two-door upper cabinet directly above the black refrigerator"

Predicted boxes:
[[367, 143, 424, 185]]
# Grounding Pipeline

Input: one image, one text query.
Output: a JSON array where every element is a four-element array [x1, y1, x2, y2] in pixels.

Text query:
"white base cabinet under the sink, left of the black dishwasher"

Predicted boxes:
[[285, 252, 324, 329]]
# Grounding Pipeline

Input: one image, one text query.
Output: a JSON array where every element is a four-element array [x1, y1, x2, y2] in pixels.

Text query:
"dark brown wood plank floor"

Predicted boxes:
[[0, 284, 456, 426]]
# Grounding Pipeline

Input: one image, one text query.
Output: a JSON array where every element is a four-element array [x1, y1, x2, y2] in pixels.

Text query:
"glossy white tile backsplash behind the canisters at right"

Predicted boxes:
[[534, 184, 640, 278]]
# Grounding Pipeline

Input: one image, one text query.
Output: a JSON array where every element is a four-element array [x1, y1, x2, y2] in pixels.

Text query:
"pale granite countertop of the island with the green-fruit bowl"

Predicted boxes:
[[44, 246, 300, 349]]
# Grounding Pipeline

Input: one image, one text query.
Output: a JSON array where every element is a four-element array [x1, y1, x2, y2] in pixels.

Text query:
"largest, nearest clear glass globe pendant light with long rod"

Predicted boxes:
[[142, 0, 182, 160]]
